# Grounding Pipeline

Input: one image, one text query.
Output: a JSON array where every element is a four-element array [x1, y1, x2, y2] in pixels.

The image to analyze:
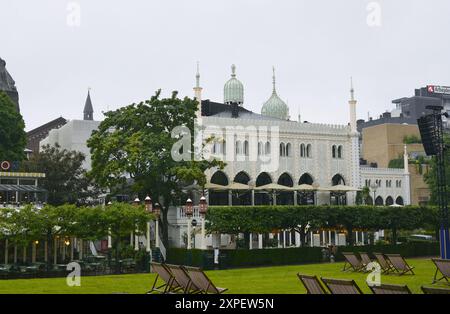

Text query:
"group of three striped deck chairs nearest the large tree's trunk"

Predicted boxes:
[[147, 262, 228, 294]]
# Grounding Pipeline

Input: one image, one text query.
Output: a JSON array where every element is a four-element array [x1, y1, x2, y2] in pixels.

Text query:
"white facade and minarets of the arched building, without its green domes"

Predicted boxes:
[[164, 66, 411, 248]]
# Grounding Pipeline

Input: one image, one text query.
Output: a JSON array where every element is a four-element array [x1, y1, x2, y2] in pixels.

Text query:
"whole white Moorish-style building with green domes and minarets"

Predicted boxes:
[[168, 65, 410, 248]]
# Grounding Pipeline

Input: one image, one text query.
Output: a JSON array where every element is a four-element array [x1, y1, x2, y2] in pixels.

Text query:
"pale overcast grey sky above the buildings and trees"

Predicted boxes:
[[0, 0, 450, 130]]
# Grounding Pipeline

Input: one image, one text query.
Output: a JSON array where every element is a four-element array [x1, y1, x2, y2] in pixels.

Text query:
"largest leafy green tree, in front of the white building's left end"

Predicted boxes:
[[88, 91, 221, 245]]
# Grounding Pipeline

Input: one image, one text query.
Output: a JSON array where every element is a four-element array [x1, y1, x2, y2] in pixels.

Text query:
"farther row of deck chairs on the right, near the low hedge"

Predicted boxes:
[[342, 252, 414, 275]]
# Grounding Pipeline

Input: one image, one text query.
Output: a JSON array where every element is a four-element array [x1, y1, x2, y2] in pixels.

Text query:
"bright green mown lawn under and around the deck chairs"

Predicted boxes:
[[0, 259, 450, 294]]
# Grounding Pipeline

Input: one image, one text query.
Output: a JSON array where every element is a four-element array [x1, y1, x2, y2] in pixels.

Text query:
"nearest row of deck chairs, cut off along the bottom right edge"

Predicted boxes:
[[297, 274, 450, 294]]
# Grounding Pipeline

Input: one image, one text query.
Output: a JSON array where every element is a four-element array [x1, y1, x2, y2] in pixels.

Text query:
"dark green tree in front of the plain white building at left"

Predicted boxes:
[[22, 144, 97, 205]]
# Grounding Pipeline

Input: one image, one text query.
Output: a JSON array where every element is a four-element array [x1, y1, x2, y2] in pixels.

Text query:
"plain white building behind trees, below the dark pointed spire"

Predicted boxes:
[[40, 120, 100, 170]]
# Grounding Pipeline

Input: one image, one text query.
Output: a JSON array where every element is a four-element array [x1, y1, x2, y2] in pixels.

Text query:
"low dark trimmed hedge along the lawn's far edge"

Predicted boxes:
[[166, 242, 439, 269]]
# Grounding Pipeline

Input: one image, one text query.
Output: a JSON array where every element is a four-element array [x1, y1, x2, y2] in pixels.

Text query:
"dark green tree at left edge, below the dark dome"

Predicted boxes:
[[0, 91, 27, 161]]
